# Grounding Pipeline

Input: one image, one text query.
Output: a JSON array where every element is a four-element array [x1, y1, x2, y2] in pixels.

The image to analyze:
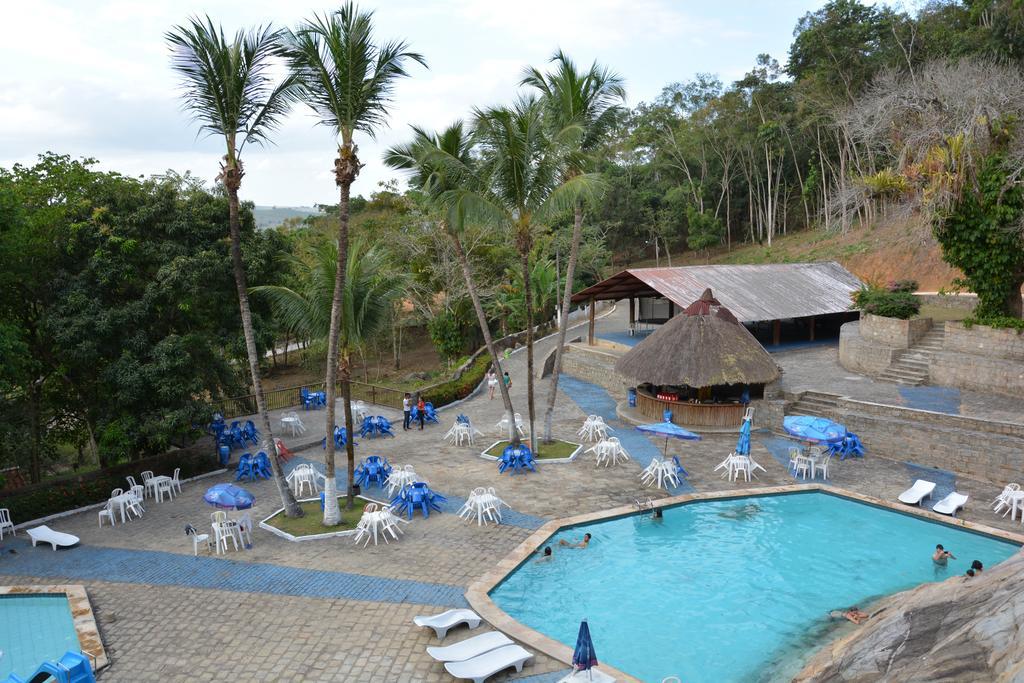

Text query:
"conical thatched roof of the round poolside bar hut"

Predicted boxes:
[[615, 289, 781, 388]]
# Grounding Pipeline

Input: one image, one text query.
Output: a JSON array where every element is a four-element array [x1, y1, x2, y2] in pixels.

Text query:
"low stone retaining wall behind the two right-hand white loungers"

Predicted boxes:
[[785, 391, 1024, 485]]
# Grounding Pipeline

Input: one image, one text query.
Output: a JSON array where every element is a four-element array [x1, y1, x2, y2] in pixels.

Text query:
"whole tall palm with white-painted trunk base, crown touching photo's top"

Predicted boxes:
[[287, 2, 426, 525]]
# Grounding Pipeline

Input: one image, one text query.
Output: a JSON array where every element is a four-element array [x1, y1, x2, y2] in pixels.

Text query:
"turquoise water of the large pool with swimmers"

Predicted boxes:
[[490, 493, 1018, 683]]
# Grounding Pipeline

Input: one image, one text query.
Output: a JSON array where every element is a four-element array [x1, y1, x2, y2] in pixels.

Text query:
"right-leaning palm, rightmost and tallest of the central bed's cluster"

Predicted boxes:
[[521, 50, 626, 442]]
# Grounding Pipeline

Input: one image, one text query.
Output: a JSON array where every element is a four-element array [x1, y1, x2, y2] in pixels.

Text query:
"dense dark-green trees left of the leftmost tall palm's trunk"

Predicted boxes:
[[0, 155, 270, 479]]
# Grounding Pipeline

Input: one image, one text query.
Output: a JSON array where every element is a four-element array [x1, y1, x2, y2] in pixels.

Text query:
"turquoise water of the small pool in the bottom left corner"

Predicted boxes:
[[0, 593, 79, 680]]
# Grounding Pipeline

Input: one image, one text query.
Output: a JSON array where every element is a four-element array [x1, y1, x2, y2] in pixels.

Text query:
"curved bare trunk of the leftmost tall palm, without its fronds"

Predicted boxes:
[[224, 176, 302, 517]]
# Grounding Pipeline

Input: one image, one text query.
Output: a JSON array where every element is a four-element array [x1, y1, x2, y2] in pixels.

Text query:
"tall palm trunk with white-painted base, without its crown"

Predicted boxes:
[[324, 150, 358, 526]]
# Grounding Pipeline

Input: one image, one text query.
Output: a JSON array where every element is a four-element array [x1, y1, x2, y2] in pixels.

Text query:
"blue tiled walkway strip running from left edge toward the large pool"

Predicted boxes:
[[0, 541, 466, 607]]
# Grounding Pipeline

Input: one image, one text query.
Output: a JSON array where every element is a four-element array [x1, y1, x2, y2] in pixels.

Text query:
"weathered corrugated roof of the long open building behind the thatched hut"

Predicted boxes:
[[572, 261, 861, 343]]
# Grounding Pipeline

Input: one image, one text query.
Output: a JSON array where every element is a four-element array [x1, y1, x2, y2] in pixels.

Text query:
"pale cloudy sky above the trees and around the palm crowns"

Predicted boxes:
[[0, 0, 822, 206]]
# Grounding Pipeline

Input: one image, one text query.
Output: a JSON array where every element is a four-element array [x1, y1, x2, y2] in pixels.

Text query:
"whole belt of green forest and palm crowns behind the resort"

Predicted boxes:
[[0, 0, 1024, 491]]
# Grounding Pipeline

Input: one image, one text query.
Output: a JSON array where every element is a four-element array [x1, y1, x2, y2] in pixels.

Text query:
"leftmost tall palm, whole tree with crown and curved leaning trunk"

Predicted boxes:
[[167, 16, 302, 517]]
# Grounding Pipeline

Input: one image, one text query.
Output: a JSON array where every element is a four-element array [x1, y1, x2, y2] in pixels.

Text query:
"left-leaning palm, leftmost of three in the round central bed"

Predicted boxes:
[[384, 121, 515, 439]]
